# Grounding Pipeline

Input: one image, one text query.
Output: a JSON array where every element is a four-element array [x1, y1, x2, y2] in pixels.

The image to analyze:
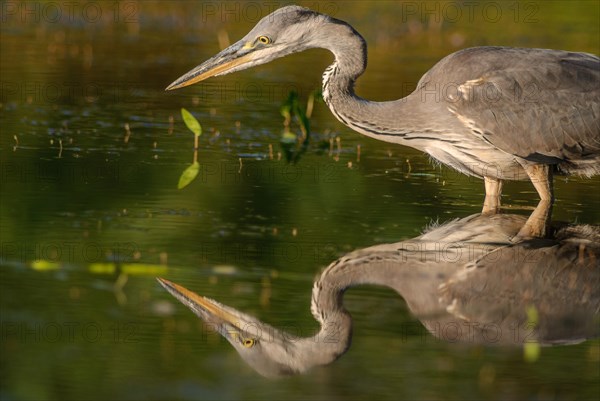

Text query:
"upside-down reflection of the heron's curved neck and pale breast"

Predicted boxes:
[[288, 215, 524, 371]]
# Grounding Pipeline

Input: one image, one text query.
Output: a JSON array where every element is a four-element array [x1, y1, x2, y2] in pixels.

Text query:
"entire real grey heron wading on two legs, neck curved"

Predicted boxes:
[[167, 6, 600, 236]]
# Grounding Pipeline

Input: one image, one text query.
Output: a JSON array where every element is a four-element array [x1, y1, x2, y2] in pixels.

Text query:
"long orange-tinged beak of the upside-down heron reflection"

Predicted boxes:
[[156, 277, 241, 330]]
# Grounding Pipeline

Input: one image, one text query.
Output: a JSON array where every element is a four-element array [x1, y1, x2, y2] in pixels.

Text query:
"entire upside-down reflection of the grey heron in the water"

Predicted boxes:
[[158, 214, 600, 376]]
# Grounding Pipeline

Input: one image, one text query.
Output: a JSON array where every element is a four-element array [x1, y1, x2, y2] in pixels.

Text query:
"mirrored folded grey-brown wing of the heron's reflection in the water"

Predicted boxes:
[[440, 226, 600, 343]]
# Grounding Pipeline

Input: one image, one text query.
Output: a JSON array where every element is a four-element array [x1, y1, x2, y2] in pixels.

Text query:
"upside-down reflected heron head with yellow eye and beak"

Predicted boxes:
[[157, 278, 336, 377]]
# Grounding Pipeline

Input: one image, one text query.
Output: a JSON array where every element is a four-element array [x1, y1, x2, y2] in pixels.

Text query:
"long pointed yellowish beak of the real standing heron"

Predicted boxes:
[[166, 42, 254, 90]]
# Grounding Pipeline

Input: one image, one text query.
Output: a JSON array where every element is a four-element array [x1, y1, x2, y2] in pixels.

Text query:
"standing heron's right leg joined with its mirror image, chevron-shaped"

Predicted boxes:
[[517, 164, 554, 238]]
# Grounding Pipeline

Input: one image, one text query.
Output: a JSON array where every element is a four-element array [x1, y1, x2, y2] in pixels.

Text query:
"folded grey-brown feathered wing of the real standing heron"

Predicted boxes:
[[448, 48, 600, 167]]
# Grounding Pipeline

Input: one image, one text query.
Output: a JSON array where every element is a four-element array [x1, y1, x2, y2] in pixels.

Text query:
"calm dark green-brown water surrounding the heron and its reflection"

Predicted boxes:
[[0, 1, 600, 400]]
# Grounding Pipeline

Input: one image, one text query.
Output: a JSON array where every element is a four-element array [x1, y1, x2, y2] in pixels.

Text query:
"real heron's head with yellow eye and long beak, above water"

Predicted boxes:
[[167, 6, 352, 90]]
